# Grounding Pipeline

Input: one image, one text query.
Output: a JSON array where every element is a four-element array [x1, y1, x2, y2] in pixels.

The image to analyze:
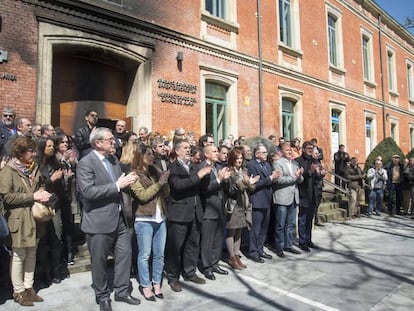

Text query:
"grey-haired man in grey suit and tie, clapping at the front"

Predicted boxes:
[[76, 127, 140, 311]]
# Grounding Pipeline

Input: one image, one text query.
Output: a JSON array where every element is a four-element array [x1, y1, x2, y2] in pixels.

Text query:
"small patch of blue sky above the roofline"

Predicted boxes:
[[374, 0, 414, 35]]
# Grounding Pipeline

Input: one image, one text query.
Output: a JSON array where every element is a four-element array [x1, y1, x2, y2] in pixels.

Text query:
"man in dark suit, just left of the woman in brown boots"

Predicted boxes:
[[200, 145, 230, 280]]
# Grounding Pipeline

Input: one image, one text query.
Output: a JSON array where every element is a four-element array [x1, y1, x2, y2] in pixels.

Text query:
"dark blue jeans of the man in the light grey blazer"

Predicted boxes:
[[275, 202, 296, 251]]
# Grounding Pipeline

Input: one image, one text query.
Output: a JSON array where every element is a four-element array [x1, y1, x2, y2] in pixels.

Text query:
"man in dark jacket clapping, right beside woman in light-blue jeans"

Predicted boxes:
[[165, 139, 211, 292]]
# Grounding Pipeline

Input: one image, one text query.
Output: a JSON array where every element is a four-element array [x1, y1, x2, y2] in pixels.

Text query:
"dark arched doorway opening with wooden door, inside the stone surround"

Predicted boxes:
[[51, 44, 138, 135]]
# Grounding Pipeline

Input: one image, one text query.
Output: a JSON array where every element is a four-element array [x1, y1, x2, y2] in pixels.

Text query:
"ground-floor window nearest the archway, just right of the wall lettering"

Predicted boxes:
[[206, 82, 227, 144]]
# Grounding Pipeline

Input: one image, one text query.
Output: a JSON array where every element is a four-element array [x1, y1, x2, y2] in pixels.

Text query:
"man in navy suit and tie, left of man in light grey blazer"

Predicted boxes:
[[247, 144, 280, 263]]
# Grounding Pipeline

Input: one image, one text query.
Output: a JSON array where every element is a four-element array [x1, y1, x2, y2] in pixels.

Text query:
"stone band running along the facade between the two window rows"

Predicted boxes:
[[20, 0, 414, 116]]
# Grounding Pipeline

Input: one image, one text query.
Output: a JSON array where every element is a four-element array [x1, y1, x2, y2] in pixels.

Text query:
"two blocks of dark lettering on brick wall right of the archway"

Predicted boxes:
[[157, 79, 197, 106]]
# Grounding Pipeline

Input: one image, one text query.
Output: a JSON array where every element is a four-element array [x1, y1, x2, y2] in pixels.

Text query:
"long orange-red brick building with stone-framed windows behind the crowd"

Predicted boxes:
[[0, 0, 414, 165]]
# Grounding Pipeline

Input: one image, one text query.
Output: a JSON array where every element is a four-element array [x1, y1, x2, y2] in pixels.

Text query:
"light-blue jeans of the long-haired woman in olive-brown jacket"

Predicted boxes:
[[134, 221, 167, 287]]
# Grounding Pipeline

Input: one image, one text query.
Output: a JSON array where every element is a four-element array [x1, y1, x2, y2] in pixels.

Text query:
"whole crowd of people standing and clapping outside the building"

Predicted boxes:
[[0, 107, 414, 311]]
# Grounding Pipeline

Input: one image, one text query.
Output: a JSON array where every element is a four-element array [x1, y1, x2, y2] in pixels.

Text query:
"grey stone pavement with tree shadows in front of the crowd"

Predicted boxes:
[[0, 216, 414, 311]]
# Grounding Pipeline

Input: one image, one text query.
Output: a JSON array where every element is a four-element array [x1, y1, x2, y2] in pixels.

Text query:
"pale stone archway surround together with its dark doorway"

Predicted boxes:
[[36, 22, 152, 133]]
